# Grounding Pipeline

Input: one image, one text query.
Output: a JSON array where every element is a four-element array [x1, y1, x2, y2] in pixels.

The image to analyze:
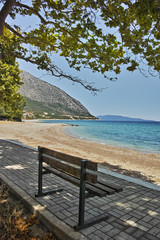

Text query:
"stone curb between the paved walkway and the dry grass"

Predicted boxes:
[[0, 173, 87, 240]]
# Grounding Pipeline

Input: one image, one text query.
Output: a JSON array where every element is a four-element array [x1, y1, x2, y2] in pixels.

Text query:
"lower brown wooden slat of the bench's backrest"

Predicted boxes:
[[43, 154, 97, 183]]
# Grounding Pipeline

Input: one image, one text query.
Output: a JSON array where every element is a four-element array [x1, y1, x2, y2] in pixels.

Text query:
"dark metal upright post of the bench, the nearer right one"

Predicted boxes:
[[78, 160, 87, 226]]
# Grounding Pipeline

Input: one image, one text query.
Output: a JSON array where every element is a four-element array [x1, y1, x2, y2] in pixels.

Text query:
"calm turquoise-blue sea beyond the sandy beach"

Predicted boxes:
[[38, 120, 160, 155]]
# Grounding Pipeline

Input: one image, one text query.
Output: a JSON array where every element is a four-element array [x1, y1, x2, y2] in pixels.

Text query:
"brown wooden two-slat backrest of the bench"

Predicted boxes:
[[38, 147, 98, 183]]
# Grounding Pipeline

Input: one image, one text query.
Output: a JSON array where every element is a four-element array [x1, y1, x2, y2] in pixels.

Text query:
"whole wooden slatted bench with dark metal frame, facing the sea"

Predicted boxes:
[[35, 147, 122, 231]]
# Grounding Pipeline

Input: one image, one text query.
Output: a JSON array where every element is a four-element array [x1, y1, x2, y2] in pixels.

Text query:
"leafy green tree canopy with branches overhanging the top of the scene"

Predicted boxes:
[[0, 0, 160, 91]]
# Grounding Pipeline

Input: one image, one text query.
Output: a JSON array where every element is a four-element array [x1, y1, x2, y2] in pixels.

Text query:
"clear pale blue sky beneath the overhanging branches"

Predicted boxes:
[[0, 1, 160, 121]]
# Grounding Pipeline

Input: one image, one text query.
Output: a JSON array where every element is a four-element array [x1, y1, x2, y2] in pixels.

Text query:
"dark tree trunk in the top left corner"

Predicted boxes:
[[0, 0, 16, 35]]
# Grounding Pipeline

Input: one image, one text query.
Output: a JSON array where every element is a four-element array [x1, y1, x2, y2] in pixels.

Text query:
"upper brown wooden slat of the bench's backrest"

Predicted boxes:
[[43, 147, 98, 171]]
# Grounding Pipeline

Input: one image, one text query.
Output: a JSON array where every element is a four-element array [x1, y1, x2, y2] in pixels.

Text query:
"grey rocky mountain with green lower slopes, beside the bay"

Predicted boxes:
[[19, 71, 95, 119]]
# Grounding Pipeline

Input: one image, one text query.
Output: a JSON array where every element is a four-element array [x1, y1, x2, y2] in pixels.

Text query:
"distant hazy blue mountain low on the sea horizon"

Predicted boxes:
[[97, 115, 154, 122]]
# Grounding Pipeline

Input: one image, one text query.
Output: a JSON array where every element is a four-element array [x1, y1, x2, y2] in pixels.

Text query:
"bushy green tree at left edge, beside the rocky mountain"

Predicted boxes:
[[0, 61, 25, 121]]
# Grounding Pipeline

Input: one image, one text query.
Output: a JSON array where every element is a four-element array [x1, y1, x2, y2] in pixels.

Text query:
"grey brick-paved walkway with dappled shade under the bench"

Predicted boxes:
[[0, 140, 160, 240]]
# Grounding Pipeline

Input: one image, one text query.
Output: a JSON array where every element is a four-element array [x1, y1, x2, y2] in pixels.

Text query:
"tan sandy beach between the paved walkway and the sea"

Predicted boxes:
[[0, 121, 160, 185]]
